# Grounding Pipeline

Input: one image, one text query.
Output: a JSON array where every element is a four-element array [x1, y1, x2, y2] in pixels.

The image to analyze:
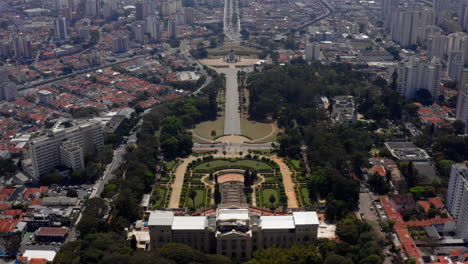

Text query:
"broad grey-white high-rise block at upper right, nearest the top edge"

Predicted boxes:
[[391, 8, 435, 48]]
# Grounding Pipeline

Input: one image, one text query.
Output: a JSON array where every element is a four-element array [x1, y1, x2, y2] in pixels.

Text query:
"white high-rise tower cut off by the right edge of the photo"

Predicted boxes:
[[446, 163, 468, 239]]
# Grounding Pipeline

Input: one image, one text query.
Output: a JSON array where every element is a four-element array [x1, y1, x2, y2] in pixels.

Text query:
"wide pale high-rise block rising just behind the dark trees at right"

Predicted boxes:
[[397, 57, 442, 99]]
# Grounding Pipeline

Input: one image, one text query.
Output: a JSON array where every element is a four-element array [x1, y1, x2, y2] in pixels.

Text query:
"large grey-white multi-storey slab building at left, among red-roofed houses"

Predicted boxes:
[[26, 120, 104, 177]]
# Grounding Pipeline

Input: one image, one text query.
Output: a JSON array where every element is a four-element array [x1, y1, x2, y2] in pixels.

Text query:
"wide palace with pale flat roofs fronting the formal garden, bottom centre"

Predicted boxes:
[[148, 207, 319, 260]]
